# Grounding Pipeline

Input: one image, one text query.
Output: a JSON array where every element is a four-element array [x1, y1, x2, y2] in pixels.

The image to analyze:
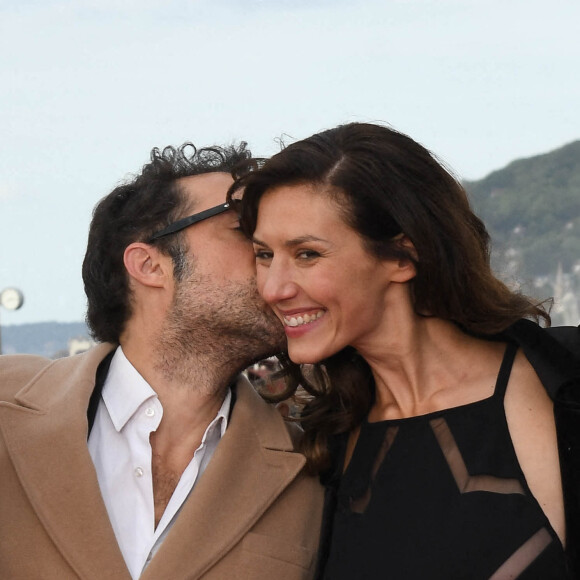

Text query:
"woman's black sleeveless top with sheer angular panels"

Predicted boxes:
[[323, 345, 570, 580]]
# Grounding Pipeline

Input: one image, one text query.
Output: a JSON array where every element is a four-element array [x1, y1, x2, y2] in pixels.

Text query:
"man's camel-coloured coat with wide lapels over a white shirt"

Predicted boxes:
[[0, 344, 323, 580]]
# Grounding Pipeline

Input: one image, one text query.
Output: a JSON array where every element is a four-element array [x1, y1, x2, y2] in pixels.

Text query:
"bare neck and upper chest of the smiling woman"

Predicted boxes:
[[361, 314, 505, 421]]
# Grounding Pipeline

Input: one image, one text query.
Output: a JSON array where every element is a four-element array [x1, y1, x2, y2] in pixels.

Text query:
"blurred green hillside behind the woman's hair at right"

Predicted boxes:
[[464, 141, 580, 283]]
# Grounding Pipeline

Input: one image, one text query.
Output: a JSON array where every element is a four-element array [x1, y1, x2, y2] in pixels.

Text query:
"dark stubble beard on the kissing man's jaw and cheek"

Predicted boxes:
[[156, 271, 286, 390]]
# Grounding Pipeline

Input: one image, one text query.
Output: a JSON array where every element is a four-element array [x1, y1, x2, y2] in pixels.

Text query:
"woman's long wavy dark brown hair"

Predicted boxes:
[[229, 123, 550, 473]]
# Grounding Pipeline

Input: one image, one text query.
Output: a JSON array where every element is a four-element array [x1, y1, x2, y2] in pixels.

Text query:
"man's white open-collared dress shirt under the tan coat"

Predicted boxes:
[[89, 347, 232, 580]]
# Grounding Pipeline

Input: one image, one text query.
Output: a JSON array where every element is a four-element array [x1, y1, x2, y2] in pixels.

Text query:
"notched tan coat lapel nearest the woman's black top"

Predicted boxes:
[[142, 379, 305, 580]]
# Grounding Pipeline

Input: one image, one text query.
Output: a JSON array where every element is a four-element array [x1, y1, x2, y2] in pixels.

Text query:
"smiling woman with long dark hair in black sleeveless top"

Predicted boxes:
[[233, 123, 572, 580]]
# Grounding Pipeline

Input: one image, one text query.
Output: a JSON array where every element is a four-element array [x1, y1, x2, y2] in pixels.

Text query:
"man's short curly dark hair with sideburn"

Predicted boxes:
[[82, 142, 251, 343]]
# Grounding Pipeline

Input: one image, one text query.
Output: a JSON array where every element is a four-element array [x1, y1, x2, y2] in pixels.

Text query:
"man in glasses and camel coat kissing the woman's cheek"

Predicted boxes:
[[0, 144, 322, 580]]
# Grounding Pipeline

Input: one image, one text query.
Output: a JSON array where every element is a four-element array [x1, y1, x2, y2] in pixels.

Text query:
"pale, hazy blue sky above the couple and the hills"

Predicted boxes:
[[0, 0, 580, 325]]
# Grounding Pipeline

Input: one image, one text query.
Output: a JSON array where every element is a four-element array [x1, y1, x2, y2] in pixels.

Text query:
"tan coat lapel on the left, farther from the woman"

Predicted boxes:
[[0, 345, 130, 580]]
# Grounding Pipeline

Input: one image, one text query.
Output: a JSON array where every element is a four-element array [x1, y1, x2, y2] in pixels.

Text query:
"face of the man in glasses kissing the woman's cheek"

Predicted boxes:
[[163, 173, 286, 374]]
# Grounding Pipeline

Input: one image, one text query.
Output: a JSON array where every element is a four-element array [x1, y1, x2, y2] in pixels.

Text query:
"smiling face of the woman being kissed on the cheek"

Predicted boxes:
[[254, 185, 408, 363]]
